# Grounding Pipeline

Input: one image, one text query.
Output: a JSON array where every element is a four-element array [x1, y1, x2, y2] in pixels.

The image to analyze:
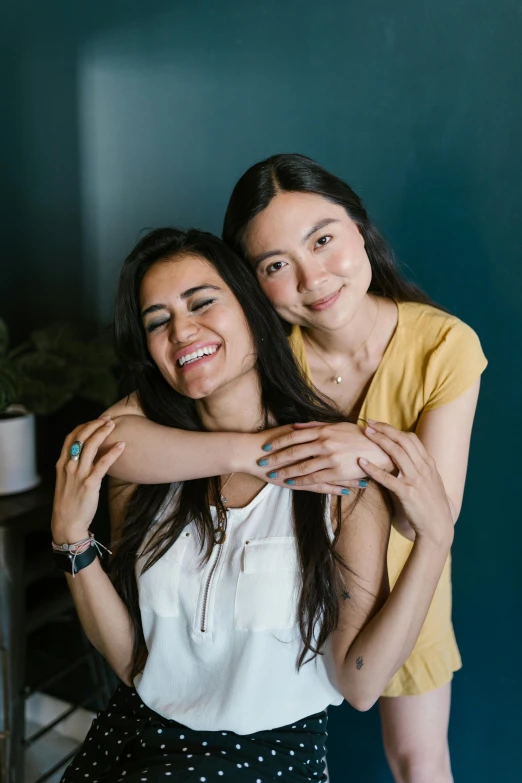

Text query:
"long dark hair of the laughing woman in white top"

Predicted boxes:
[[111, 228, 360, 674]]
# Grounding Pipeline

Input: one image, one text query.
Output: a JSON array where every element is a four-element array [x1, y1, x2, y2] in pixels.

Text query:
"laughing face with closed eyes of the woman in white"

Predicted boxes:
[[140, 255, 256, 400]]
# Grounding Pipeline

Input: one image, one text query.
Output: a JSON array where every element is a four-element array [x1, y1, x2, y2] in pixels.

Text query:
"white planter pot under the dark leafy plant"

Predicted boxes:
[[0, 406, 40, 495]]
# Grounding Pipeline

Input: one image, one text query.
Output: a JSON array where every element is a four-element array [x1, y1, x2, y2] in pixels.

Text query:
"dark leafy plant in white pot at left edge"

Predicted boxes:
[[0, 319, 117, 495]]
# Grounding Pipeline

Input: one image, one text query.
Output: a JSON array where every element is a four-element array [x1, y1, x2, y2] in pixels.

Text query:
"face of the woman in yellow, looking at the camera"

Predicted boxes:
[[245, 191, 372, 331]]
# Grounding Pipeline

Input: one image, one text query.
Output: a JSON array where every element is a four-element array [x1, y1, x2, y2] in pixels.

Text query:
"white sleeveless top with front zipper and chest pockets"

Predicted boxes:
[[134, 484, 343, 734]]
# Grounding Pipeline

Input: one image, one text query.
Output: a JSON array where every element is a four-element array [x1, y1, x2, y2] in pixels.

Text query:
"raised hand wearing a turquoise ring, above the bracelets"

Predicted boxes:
[[51, 418, 125, 544]]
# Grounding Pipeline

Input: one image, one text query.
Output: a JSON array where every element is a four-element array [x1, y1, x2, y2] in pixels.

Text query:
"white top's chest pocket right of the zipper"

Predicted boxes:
[[234, 536, 300, 631]]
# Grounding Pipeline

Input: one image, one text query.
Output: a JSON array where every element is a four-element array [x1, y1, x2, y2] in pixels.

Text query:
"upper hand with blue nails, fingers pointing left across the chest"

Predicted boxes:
[[254, 421, 395, 489]]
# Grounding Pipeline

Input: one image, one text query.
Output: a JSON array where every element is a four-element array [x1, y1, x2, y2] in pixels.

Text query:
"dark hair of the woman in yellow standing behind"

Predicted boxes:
[[219, 154, 438, 322]]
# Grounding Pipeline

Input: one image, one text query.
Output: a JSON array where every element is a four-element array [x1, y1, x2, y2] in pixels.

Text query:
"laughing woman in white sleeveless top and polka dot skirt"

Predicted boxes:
[[52, 229, 453, 783]]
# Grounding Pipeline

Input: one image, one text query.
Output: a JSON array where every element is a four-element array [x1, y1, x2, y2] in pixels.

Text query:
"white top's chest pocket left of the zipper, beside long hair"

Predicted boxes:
[[136, 533, 190, 617]]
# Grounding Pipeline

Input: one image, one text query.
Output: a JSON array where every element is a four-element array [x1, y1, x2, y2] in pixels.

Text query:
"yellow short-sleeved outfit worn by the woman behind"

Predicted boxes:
[[290, 302, 487, 696]]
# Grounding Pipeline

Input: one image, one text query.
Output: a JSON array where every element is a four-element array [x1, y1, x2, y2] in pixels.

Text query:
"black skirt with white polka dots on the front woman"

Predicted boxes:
[[61, 685, 327, 783]]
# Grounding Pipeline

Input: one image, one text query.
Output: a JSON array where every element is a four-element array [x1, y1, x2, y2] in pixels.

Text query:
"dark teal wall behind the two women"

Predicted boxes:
[[0, 0, 522, 783]]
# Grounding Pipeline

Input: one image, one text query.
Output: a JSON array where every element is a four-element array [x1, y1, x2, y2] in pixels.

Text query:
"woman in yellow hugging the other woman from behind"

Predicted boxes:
[[100, 155, 486, 783]]
